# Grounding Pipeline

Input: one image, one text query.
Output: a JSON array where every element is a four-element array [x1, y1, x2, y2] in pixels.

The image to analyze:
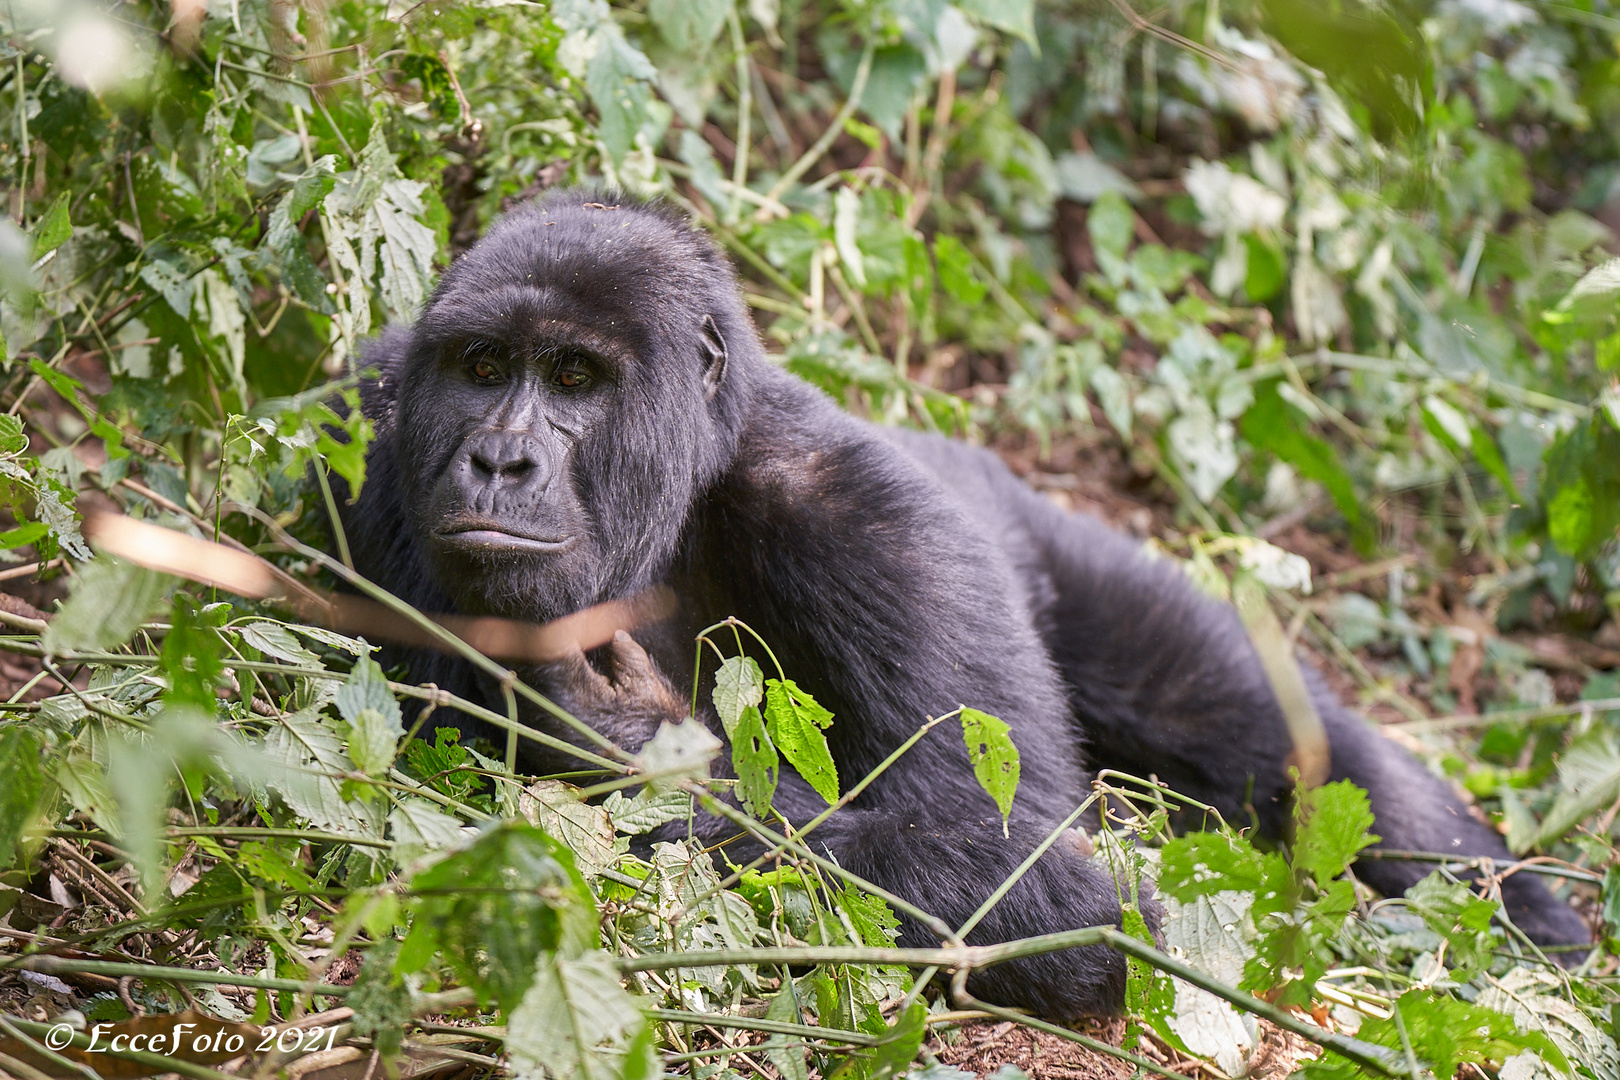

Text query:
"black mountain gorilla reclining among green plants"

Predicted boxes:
[[335, 191, 1588, 1017]]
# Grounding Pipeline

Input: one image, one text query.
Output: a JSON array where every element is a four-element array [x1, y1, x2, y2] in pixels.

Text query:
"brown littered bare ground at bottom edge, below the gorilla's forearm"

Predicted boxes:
[[930, 1018, 1319, 1080]]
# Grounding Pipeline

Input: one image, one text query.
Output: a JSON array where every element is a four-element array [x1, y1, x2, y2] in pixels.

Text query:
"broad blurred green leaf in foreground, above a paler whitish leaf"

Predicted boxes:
[[397, 821, 596, 1012]]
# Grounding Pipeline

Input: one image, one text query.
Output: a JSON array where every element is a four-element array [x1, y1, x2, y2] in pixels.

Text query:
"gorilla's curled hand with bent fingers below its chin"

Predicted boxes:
[[538, 630, 690, 753]]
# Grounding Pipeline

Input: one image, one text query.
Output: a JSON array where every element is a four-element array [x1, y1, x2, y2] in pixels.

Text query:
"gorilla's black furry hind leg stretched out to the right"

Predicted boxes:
[[1030, 507, 1589, 944]]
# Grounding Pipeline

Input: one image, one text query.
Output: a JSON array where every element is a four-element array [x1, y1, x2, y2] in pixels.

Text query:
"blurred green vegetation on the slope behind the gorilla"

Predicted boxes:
[[0, 0, 1620, 1075]]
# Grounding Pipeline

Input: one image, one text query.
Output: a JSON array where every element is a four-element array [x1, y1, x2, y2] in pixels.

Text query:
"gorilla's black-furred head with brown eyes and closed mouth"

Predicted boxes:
[[392, 191, 760, 619]]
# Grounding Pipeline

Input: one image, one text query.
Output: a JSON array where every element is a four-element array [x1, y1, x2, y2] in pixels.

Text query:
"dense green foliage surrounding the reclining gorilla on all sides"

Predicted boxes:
[[0, 0, 1620, 1080]]
